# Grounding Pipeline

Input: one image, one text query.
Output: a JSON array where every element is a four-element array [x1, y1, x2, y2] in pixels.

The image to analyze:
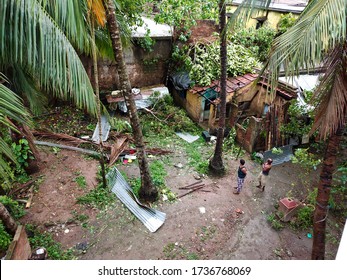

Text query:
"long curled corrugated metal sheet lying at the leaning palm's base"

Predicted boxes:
[[106, 167, 166, 232]]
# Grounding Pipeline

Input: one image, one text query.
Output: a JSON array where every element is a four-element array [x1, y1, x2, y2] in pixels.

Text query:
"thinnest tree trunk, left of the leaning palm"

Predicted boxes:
[[90, 18, 107, 188]]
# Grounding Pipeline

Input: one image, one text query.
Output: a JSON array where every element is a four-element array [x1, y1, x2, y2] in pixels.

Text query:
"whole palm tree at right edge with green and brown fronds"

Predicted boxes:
[[264, 0, 347, 259]]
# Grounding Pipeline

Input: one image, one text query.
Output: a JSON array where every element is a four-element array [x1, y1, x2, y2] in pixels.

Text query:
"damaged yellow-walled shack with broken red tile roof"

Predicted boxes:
[[170, 73, 297, 153]]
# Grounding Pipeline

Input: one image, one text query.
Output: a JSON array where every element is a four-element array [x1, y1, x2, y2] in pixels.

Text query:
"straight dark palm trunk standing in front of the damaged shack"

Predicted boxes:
[[209, 0, 227, 175]]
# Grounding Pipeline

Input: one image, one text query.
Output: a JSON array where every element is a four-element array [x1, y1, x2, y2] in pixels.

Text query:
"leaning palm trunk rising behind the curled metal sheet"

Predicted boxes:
[[104, 0, 158, 201]]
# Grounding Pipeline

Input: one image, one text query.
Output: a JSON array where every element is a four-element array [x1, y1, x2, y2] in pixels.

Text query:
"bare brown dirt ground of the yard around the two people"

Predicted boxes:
[[21, 144, 343, 260]]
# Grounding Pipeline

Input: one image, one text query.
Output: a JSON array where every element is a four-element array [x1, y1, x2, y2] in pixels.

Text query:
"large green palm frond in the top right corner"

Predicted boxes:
[[262, 0, 347, 88]]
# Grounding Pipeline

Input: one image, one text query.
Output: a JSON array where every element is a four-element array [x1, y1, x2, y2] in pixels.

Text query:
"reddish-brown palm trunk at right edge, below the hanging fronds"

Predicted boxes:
[[311, 124, 343, 260]]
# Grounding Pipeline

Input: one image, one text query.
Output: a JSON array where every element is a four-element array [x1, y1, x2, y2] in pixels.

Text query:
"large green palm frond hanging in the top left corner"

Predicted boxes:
[[0, 0, 96, 115]]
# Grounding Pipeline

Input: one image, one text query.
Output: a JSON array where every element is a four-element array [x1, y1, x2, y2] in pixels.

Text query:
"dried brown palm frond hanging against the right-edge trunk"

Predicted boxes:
[[311, 45, 347, 139]]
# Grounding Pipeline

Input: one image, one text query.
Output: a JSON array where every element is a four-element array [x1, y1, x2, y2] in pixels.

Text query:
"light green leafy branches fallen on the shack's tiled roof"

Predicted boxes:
[[189, 42, 259, 86]]
